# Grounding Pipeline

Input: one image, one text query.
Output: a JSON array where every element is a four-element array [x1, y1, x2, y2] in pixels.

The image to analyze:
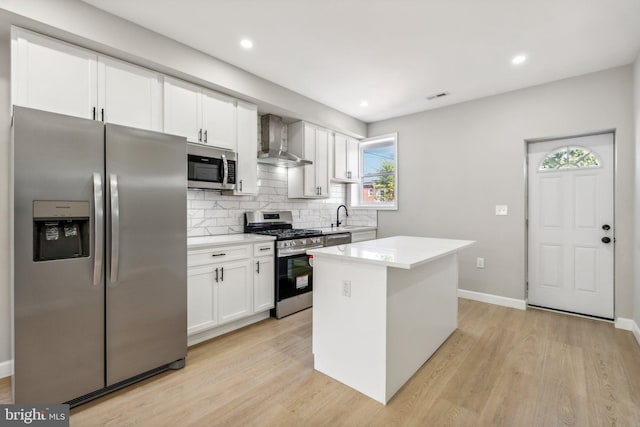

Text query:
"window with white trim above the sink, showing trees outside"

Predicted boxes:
[[350, 134, 398, 210]]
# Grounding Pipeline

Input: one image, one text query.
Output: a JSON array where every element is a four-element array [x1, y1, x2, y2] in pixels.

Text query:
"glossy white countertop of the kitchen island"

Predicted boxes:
[[307, 236, 475, 269]]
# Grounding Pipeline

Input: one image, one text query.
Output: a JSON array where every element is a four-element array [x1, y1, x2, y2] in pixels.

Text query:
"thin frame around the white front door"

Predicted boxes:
[[523, 128, 618, 321]]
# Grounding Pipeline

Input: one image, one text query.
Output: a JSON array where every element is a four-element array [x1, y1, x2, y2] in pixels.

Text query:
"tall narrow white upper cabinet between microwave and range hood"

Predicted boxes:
[[234, 101, 258, 195]]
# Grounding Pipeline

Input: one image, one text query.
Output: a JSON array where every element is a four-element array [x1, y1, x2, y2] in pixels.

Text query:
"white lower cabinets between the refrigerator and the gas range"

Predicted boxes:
[[187, 241, 275, 345]]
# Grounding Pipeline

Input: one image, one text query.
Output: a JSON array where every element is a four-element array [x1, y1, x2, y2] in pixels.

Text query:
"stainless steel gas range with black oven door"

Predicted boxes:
[[244, 211, 324, 319]]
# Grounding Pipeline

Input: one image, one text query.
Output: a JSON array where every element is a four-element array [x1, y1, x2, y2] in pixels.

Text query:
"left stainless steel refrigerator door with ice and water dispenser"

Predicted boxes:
[[12, 107, 104, 403]]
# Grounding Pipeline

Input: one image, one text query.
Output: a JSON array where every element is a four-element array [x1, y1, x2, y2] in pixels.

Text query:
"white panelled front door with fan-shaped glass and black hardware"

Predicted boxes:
[[528, 133, 614, 319]]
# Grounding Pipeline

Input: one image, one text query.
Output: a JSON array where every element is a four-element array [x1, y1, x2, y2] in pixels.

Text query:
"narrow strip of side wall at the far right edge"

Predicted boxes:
[[633, 53, 640, 325]]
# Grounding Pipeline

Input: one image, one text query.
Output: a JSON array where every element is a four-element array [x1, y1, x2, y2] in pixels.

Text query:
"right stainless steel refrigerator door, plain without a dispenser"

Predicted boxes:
[[106, 124, 187, 386]]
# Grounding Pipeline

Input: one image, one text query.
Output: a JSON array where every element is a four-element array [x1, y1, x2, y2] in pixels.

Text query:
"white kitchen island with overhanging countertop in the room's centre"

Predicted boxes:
[[307, 236, 475, 404]]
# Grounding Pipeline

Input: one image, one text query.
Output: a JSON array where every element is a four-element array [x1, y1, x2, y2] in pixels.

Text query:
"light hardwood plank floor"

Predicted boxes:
[[0, 300, 640, 427]]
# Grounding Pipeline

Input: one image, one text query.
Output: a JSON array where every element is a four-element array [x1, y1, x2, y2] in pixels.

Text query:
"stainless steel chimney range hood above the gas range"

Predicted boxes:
[[258, 114, 313, 168]]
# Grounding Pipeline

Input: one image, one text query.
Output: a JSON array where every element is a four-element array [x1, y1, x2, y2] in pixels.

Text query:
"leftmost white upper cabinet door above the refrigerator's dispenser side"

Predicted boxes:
[[11, 27, 98, 119]]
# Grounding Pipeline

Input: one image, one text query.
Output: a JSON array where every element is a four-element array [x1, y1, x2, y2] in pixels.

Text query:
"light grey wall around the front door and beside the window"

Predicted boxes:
[[368, 66, 634, 318]]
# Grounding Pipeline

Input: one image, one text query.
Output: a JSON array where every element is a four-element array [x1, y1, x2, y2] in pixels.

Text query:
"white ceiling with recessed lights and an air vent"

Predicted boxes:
[[83, 0, 640, 122]]
